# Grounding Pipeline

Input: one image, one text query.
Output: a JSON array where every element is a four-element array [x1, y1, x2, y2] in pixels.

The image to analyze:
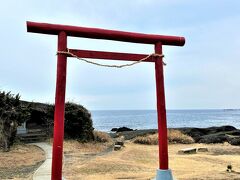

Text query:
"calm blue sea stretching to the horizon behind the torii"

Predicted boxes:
[[91, 110, 240, 131]]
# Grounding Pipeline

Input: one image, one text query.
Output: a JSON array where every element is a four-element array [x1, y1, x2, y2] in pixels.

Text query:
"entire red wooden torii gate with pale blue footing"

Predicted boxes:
[[27, 21, 185, 180]]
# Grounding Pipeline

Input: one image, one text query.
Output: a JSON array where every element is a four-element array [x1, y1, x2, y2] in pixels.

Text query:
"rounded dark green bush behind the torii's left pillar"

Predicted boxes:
[[23, 101, 94, 142]]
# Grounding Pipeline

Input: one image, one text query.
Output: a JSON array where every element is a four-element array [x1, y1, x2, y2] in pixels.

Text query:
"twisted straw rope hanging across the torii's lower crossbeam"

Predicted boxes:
[[57, 49, 167, 68]]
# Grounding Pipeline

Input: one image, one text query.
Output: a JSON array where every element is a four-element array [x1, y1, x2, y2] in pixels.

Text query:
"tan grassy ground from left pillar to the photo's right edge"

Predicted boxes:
[[64, 142, 240, 180]]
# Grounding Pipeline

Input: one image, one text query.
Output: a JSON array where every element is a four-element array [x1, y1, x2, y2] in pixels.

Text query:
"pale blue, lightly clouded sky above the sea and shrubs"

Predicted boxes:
[[0, 0, 240, 110]]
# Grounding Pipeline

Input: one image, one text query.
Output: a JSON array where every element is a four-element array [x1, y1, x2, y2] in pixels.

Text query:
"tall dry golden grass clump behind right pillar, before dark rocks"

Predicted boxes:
[[133, 129, 194, 145]]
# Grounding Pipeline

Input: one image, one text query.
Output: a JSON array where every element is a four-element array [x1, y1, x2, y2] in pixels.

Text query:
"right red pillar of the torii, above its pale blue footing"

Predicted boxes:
[[155, 42, 168, 170]]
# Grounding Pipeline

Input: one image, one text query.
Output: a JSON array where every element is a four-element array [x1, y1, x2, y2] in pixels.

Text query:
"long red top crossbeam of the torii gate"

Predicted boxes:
[[27, 21, 185, 46]]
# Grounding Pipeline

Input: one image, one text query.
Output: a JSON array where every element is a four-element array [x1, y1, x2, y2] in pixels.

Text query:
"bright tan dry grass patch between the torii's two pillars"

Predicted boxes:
[[64, 142, 157, 180]]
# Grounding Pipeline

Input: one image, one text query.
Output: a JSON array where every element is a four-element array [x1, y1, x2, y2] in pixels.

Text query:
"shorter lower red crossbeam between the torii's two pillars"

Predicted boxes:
[[69, 49, 155, 62]]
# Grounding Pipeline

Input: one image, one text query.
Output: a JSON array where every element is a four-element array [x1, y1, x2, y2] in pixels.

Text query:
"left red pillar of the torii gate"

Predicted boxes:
[[52, 31, 67, 180]]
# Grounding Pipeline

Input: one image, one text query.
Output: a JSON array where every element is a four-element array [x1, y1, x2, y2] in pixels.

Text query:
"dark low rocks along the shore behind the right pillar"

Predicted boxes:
[[109, 126, 240, 146]]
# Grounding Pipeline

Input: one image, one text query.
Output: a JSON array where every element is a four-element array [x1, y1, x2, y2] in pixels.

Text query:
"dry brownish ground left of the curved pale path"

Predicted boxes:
[[0, 145, 45, 180]]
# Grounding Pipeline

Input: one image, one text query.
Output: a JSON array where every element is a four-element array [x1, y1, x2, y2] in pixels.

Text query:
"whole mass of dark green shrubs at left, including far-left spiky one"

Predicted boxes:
[[0, 91, 94, 151]]
